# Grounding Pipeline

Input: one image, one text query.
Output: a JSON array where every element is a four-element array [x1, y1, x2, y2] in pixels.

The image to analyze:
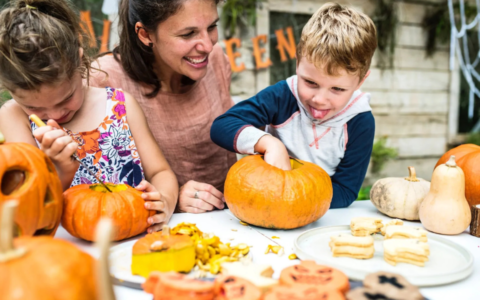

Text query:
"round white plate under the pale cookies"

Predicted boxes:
[[295, 225, 473, 286]]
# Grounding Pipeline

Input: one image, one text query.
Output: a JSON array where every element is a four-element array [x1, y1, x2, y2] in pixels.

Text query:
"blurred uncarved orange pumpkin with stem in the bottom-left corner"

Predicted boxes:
[[0, 201, 98, 300]]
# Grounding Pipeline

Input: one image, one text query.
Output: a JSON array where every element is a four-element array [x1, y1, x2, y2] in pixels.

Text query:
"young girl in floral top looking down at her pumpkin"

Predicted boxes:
[[0, 0, 178, 232]]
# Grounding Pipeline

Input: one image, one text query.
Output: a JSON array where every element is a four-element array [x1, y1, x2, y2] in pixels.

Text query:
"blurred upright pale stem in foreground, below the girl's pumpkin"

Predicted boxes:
[[95, 218, 115, 300]]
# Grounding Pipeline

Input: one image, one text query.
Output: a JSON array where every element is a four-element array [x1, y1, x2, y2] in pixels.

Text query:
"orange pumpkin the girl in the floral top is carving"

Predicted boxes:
[[62, 183, 155, 241]]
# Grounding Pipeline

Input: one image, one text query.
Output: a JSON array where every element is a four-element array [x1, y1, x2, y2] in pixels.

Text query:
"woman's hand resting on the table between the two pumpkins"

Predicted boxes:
[[178, 180, 225, 214]]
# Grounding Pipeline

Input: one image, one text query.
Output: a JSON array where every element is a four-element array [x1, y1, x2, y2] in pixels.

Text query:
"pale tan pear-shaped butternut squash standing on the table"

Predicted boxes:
[[420, 155, 472, 234]]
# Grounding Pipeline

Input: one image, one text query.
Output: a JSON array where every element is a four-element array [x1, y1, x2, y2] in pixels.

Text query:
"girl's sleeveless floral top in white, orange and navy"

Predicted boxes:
[[30, 87, 144, 187]]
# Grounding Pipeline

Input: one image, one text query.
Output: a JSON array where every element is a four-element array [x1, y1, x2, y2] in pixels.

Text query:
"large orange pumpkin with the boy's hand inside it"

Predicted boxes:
[[225, 155, 333, 229]]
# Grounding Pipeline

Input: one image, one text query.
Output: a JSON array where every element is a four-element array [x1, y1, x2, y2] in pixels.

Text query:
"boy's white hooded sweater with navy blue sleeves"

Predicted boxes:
[[210, 76, 375, 208]]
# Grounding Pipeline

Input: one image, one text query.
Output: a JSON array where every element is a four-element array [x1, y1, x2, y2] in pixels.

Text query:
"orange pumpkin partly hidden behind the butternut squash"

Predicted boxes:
[[435, 144, 480, 206]]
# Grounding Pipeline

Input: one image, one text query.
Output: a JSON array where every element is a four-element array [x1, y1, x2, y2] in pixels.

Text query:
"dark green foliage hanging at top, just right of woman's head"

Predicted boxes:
[[221, 0, 265, 39]]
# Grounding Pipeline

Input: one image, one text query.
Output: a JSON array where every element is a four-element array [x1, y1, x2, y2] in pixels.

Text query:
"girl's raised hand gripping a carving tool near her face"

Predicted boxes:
[[33, 120, 78, 170]]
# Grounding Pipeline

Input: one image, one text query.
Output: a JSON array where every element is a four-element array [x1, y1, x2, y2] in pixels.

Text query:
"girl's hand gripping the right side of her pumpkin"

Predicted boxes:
[[135, 180, 171, 233]]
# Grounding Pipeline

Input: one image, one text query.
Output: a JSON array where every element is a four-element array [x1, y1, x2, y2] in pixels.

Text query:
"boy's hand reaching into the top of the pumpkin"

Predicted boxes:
[[255, 135, 292, 171]]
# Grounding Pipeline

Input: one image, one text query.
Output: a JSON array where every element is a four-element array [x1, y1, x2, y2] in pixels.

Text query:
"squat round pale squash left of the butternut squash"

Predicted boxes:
[[370, 167, 430, 221]]
